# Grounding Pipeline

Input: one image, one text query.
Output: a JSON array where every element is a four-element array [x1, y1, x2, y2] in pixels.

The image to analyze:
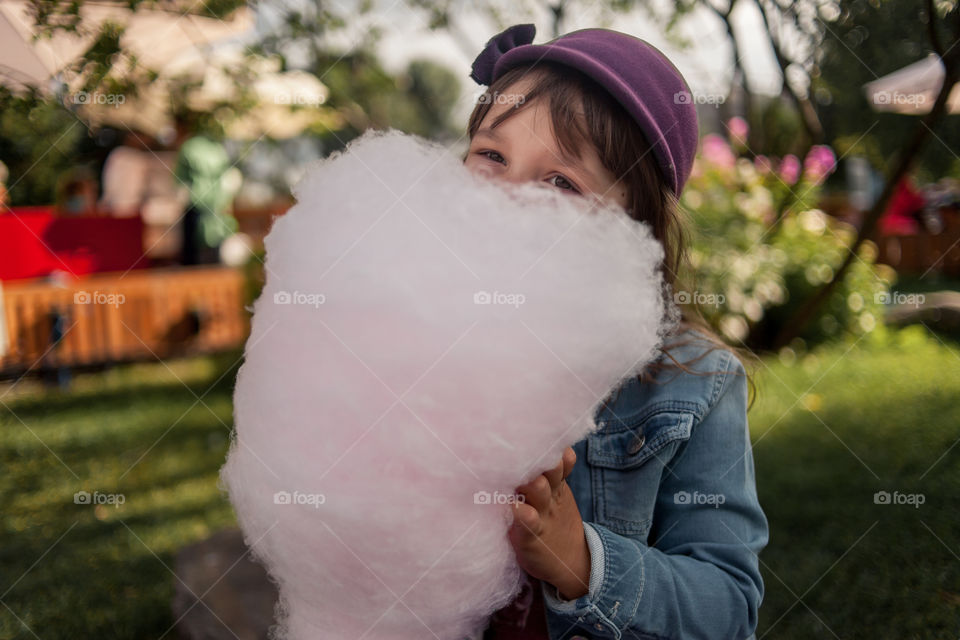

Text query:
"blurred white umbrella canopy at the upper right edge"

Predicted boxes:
[[863, 53, 960, 115]]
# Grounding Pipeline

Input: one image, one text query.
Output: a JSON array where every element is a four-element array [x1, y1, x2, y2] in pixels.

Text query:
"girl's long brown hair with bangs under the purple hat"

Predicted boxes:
[[464, 61, 758, 408]]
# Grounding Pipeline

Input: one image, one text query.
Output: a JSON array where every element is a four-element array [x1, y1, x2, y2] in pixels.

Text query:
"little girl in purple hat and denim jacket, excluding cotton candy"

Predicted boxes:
[[464, 24, 768, 640]]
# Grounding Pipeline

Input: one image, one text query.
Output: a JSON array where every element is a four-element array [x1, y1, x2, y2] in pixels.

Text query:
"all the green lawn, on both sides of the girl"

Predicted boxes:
[[0, 327, 960, 640]]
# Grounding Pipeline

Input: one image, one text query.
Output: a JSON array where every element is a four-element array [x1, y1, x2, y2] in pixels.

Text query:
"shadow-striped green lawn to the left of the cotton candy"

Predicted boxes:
[[0, 354, 238, 640]]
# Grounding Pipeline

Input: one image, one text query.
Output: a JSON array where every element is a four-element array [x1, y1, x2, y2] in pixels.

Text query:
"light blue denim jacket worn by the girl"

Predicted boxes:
[[543, 332, 768, 640]]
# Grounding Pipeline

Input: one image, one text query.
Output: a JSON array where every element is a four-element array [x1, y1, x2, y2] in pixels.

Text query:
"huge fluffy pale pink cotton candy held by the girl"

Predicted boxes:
[[221, 130, 677, 640]]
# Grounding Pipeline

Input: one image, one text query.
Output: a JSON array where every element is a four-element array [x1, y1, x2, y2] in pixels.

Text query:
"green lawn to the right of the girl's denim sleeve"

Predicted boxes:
[[750, 327, 960, 640]]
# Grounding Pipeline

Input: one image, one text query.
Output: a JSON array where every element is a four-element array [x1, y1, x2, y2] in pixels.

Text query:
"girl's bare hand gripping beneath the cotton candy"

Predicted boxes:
[[509, 447, 590, 600]]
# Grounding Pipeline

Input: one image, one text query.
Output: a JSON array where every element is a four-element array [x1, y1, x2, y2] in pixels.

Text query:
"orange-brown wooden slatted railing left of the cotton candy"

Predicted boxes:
[[0, 266, 248, 376]]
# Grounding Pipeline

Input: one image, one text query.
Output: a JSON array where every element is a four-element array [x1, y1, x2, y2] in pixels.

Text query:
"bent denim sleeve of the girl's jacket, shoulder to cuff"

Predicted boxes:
[[543, 351, 768, 640]]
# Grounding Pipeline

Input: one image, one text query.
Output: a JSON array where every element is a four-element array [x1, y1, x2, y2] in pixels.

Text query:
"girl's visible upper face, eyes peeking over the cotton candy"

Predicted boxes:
[[464, 80, 627, 208]]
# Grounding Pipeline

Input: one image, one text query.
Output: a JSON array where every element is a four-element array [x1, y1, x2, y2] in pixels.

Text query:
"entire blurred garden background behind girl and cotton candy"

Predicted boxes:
[[0, 0, 960, 640]]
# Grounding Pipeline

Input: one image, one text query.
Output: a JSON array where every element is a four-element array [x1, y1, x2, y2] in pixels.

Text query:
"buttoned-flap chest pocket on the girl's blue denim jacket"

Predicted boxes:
[[587, 410, 694, 539]]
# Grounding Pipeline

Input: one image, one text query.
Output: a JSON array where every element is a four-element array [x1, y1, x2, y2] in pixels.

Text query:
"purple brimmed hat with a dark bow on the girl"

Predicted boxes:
[[470, 24, 698, 196]]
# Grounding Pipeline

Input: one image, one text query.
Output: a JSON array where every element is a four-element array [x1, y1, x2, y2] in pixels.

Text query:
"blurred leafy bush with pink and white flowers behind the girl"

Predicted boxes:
[[675, 119, 895, 351]]
